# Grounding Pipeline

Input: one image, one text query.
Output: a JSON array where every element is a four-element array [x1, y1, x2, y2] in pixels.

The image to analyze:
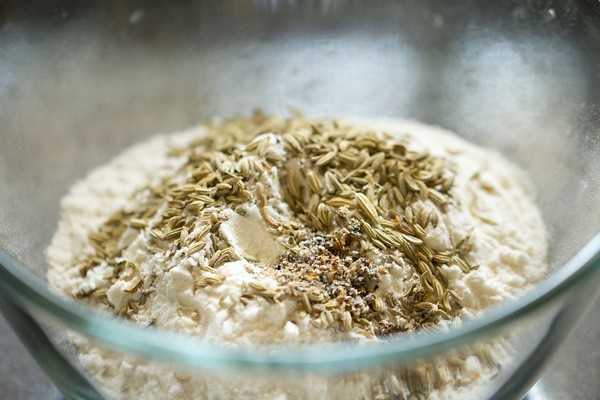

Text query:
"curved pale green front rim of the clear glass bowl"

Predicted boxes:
[[0, 233, 600, 372]]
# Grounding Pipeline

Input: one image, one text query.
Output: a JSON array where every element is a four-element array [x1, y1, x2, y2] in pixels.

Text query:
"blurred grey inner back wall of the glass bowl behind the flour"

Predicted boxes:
[[0, 1, 600, 328]]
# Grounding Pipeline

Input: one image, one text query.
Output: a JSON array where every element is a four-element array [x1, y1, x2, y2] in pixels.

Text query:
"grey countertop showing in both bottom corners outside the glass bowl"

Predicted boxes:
[[0, 299, 600, 400]]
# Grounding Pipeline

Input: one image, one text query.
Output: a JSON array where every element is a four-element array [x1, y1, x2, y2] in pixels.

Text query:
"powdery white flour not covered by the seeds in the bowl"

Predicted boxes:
[[48, 117, 547, 399]]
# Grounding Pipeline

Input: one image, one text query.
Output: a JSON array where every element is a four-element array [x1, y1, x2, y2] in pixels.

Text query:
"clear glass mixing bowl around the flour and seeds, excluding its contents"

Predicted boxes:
[[0, 0, 600, 399]]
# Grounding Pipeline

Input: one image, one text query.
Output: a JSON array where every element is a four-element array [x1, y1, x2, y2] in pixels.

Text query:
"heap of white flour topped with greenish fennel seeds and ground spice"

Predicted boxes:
[[48, 113, 546, 398]]
